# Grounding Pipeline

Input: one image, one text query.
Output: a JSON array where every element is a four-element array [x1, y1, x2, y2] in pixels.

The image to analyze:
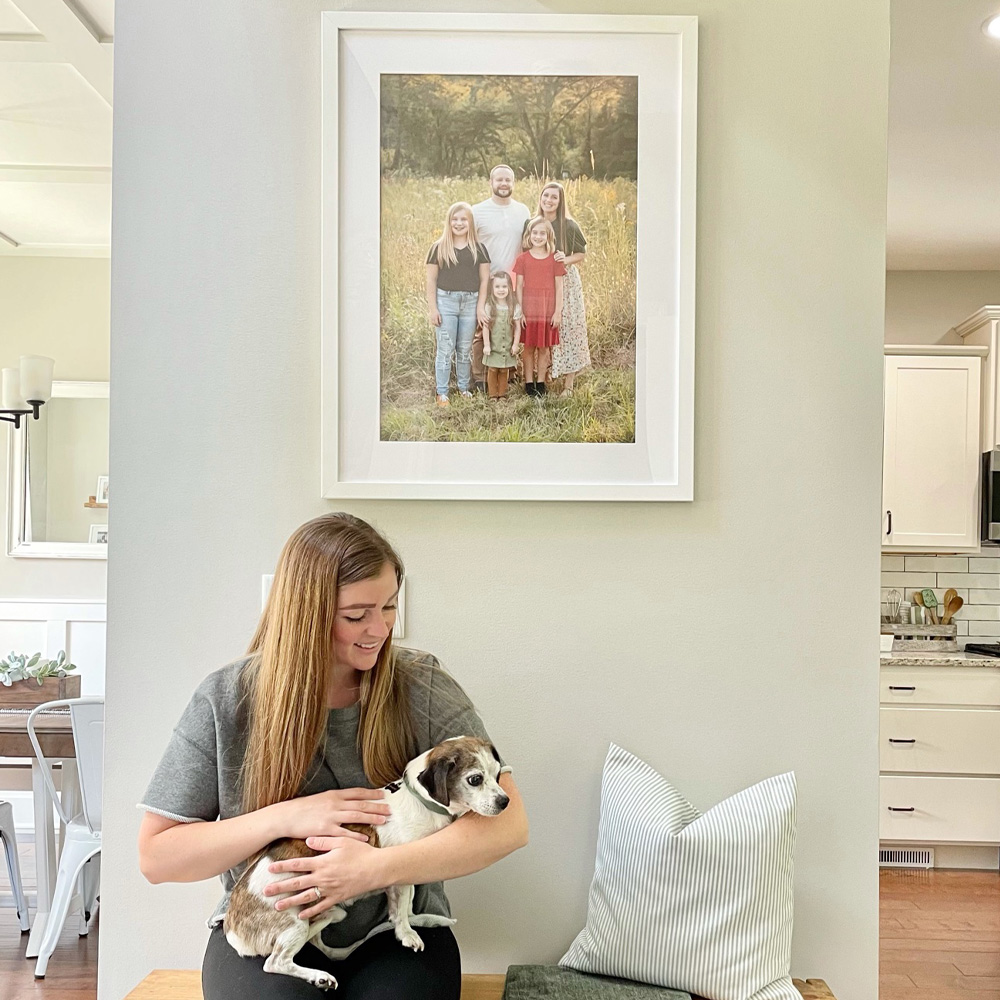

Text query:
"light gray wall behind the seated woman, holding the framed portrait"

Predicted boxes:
[[100, 0, 889, 1000]]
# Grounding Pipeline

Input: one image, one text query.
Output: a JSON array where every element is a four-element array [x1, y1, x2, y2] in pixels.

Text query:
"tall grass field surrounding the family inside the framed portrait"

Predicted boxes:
[[381, 175, 636, 442]]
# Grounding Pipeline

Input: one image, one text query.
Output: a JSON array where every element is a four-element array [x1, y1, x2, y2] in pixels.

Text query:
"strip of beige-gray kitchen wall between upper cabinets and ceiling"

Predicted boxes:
[[885, 271, 1000, 344]]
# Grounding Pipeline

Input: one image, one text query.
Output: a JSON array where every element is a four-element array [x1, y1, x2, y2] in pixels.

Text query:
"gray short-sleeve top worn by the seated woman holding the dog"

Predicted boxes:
[[139, 647, 510, 955]]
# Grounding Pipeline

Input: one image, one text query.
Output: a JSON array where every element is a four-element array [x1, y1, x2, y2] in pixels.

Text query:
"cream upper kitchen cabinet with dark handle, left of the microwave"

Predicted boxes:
[[882, 348, 982, 552]]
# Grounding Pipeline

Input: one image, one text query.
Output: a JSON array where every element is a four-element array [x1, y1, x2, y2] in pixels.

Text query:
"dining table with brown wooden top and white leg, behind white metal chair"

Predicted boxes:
[[0, 704, 79, 958]]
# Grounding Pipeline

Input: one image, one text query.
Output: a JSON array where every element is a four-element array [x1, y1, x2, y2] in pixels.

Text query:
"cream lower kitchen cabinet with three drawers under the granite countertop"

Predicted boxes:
[[879, 663, 1000, 847]]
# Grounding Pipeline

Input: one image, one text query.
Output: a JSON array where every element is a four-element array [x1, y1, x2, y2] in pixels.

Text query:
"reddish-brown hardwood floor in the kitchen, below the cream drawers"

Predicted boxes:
[[879, 868, 1000, 1000]]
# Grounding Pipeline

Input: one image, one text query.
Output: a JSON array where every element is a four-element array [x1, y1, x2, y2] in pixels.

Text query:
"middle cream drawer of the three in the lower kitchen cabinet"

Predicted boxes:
[[879, 707, 1000, 775]]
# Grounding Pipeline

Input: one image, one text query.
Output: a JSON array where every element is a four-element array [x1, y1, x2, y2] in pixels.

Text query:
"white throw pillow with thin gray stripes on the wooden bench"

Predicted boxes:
[[559, 743, 801, 1000]]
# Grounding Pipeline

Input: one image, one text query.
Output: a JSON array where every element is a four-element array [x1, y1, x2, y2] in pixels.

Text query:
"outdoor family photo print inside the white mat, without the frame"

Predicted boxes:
[[380, 74, 638, 443]]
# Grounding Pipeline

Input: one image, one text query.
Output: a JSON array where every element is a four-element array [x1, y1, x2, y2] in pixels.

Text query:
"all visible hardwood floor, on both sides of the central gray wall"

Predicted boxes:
[[0, 845, 1000, 1000]]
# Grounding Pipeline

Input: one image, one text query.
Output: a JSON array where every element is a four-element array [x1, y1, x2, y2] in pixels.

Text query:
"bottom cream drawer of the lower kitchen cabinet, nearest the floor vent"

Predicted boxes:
[[879, 775, 1000, 844]]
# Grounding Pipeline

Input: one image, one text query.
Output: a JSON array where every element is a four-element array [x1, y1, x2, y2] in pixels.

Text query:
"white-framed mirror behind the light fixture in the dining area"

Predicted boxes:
[[7, 382, 110, 559]]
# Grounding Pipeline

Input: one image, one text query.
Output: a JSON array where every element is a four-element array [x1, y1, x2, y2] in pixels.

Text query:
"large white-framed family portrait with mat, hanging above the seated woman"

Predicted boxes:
[[321, 11, 698, 501]]
